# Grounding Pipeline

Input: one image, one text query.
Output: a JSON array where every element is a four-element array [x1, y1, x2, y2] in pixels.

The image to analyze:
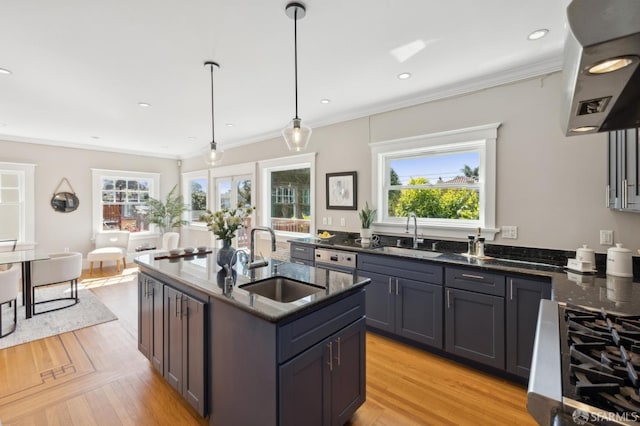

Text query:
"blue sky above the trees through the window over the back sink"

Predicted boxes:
[[391, 152, 480, 184]]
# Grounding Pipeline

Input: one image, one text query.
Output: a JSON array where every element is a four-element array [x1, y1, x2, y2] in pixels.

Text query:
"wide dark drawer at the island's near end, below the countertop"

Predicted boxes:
[[278, 290, 365, 363]]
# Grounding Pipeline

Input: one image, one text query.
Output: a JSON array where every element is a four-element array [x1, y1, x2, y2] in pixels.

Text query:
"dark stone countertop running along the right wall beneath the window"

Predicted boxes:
[[290, 238, 640, 315]]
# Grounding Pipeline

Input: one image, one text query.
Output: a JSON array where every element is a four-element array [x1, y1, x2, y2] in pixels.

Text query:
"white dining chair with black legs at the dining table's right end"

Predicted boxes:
[[31, 252, 82, 315]]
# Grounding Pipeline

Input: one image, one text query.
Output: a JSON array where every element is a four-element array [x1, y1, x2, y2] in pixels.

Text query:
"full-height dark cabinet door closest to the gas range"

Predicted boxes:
[[506, 277, 551, 377]]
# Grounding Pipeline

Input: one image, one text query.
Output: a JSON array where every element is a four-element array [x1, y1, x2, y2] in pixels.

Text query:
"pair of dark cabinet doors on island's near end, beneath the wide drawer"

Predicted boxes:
[[279, 319, 365, 426]]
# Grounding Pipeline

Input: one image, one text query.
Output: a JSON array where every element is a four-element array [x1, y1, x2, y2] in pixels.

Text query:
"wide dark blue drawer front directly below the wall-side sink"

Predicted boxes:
[[358, 254, 443, 284]]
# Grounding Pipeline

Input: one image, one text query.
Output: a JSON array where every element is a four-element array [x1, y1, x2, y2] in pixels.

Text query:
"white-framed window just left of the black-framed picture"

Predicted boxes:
[[260, 154, 315, 234]]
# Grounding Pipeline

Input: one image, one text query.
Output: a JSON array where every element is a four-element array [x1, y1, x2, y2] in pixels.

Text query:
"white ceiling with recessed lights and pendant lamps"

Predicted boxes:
[[0, 0, 569, 158]]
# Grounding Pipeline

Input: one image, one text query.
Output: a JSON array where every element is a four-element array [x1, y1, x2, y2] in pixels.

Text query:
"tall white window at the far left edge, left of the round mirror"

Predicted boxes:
[[0, 163, 35, 243]]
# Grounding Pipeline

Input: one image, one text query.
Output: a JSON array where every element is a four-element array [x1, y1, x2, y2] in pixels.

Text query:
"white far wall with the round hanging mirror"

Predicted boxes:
[[0, 141, 179, 256]]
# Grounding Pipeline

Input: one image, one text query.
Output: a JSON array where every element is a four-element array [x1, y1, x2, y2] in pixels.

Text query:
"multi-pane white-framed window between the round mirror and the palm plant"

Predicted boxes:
[[92, 169, 160, 232]]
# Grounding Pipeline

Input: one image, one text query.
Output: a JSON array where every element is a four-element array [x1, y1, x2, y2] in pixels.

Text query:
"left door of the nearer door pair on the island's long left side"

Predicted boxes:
[[164, 285, 183, 393]]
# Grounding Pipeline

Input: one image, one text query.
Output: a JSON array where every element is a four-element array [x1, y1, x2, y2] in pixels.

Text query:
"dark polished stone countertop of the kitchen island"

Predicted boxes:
[[135, 249, 370, 322]]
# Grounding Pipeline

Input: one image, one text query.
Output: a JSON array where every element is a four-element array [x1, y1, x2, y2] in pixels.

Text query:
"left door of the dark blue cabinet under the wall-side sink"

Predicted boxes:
[[360, 271, 395, 333]]
